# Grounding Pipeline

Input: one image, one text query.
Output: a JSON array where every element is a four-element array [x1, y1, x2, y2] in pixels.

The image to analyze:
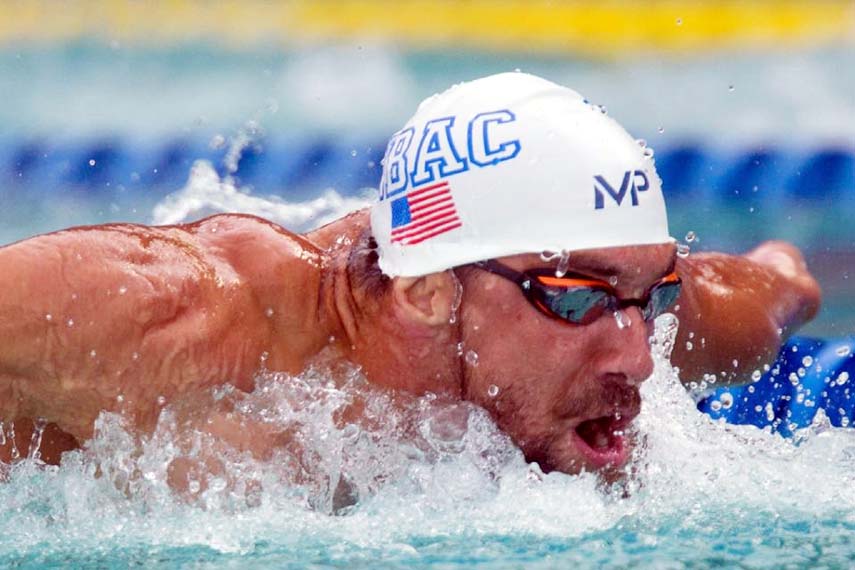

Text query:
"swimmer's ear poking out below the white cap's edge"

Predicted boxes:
[[392, 271, 457, 326]]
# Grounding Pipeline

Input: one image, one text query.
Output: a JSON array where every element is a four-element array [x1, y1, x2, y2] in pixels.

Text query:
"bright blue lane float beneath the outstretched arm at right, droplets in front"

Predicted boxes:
[[698, 336, 855, 437]]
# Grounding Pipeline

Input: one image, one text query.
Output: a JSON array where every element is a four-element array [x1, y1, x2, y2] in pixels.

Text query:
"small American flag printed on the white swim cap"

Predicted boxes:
[[391, 182, 463, 245]]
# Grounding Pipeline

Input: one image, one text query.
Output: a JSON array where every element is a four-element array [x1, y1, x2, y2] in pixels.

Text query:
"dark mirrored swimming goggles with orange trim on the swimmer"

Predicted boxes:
[[473, 260, 682, 325]]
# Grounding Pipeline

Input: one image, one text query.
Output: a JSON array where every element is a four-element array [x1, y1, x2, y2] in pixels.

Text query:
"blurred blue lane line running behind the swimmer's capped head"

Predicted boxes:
[[0, 136, 855, 201]]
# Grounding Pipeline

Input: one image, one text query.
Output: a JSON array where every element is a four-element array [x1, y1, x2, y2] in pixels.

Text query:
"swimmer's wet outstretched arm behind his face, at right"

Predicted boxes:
[[672, 237, 821, 384]]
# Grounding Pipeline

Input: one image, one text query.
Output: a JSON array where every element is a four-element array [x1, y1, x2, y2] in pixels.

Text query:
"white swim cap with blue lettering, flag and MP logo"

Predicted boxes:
[[371, 73, 673, 277]]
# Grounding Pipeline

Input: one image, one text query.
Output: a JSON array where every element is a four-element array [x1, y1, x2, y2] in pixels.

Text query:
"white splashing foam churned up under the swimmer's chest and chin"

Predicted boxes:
[[0, 310, 855, 556]]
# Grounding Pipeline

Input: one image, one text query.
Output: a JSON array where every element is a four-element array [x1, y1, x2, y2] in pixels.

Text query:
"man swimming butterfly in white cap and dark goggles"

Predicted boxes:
[[0, 73, 820, 473]]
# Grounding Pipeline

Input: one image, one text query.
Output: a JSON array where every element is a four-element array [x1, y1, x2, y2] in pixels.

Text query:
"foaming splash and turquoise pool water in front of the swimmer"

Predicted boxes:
[[5, 315, 855, 568]]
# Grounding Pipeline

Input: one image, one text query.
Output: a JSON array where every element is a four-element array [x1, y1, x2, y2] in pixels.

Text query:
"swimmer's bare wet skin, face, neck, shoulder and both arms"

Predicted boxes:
[[0, 212, 819, 473]]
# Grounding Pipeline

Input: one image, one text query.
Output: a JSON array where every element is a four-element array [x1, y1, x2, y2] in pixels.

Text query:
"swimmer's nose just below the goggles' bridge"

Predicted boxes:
[[598, 307, 653, 385]]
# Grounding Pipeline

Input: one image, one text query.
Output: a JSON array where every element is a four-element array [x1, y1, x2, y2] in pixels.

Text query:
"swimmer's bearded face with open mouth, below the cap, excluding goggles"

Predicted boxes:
[[460, 244, 675, 473]]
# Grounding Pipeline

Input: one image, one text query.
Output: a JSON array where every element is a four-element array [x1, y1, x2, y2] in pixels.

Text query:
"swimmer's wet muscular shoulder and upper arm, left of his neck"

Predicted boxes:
[[0, 216, 326, 441]]
